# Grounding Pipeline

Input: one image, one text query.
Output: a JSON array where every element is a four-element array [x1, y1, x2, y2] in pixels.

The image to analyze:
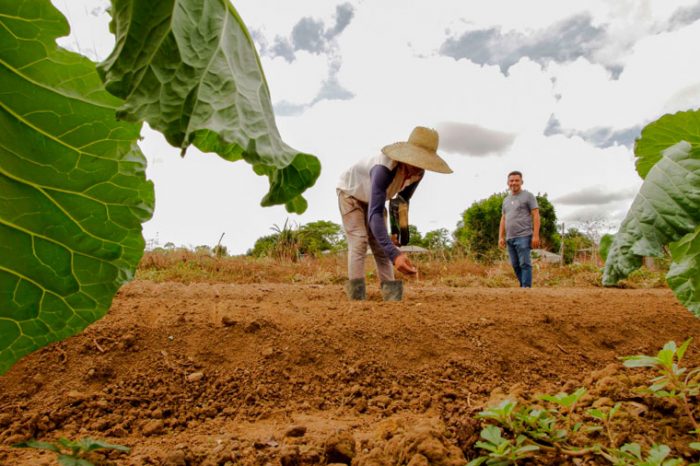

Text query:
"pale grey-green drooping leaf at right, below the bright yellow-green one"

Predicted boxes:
[[603, 142, 700, 285]]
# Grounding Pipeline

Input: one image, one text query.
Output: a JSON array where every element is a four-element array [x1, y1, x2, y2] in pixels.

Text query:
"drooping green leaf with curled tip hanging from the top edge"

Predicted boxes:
[[99, 0, 321, 213]]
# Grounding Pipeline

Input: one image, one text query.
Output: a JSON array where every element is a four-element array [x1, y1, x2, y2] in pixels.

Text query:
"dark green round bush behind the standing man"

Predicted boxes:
[[454, 192, 560, 261]]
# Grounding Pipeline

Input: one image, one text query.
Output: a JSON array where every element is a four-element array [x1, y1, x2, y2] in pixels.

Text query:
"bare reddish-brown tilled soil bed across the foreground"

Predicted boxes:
[[0, 281, 700, 465]]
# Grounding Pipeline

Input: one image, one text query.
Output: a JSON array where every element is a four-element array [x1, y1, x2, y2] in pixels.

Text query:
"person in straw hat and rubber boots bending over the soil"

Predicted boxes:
[[337, 126, 452, 301]]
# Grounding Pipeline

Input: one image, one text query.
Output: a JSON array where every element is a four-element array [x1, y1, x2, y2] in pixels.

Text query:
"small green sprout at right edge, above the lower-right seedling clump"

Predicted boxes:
[[622, 338, 700, 435]]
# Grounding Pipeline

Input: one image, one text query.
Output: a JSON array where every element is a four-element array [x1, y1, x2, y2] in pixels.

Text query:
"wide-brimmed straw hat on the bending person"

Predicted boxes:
[[382, 126, 452, 173]]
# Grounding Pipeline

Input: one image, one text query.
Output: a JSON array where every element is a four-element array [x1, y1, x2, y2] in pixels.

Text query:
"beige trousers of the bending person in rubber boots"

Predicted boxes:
[[338, 191, 394, 281]]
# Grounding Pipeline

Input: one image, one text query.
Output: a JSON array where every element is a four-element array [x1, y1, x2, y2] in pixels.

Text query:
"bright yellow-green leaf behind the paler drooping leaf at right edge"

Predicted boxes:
[[634, 110, 700, 178]]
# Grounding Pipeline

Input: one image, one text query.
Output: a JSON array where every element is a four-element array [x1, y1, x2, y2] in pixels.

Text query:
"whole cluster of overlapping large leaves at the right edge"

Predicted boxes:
[[603, 111, 700, 316]]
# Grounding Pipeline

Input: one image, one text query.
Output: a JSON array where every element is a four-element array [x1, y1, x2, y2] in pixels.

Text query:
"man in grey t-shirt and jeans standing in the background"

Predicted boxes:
[[498, 171, 540, 288]]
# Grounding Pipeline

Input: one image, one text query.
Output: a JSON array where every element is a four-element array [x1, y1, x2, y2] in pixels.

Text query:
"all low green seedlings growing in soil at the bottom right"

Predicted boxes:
[[469, 339, 700, 466]]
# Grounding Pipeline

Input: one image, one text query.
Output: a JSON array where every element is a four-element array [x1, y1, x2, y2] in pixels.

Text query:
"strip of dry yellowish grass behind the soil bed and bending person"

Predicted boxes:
[[136, 250, 666, 288]]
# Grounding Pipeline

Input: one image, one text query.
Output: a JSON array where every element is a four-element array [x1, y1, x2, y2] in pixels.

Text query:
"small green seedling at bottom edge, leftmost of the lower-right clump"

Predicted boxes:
[[467, 426, 539, 466]]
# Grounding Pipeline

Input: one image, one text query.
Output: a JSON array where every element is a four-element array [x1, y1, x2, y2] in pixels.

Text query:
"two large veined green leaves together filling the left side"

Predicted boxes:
[[0, 0, 320, 374]]
